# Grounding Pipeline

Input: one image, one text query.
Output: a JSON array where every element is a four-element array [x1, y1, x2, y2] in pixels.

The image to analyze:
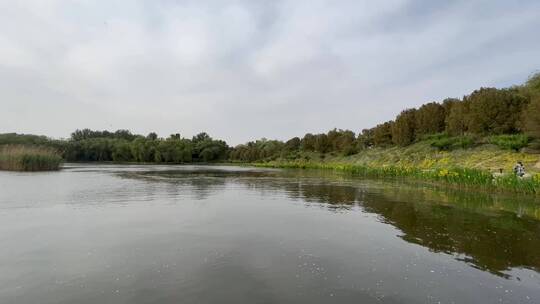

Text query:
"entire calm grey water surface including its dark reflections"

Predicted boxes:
[[0, 165, 540, 304]]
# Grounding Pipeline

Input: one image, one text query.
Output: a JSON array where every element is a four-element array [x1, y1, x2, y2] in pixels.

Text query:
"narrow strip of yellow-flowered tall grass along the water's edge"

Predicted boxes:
[[255, 161, 540, 194]]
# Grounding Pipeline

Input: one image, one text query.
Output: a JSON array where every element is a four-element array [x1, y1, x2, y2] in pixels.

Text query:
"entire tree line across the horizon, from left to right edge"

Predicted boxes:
[[0, 73, 540, 163]]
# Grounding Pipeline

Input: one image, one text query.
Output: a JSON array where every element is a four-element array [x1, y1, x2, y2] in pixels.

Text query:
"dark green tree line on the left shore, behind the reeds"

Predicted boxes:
[[0, 129, 230, 163]]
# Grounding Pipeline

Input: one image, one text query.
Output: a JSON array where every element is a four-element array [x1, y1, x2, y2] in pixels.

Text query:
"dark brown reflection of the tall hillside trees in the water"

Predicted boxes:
[[358, 191, 540, 275]]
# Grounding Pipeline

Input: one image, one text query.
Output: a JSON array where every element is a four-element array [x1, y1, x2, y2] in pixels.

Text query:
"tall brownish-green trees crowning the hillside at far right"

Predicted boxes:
[[361, 74, 540, 146]]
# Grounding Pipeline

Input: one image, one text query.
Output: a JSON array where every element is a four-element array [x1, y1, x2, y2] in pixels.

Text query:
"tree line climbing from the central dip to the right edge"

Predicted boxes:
[[230, 73, 540, 161]]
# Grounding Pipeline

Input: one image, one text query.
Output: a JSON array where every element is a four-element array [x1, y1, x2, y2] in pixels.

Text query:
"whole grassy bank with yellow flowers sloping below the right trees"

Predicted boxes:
[[255, 142, 540, 194]]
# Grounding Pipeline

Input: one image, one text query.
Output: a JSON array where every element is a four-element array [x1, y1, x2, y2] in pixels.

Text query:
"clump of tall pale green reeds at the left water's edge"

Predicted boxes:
[[0, 145, 62, 171]]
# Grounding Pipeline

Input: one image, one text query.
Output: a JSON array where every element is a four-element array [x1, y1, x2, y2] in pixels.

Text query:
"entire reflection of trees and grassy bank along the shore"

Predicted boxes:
[[122, 171, 540, 276]]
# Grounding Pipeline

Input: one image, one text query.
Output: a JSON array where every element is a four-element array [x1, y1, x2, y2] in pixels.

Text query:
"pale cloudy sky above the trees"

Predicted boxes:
[[0, 0, 540, 145]]
